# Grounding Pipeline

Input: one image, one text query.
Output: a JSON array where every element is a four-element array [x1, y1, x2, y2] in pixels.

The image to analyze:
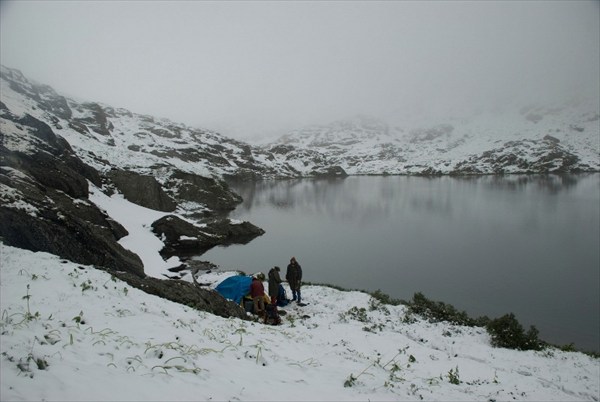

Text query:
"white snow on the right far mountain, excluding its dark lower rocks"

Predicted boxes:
[[267, 99, 600, 175]]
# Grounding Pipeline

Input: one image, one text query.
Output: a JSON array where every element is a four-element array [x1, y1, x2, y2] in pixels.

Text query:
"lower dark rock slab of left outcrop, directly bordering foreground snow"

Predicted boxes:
[[0, 173, 144, 275]]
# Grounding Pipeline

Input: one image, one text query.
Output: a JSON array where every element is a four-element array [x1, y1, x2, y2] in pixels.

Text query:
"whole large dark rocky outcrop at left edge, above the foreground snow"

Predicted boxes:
[[0, 110, 144, 275]]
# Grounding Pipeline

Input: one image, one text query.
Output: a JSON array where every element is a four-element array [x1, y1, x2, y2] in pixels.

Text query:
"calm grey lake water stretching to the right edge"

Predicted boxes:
[[199, 174, 600, 351]]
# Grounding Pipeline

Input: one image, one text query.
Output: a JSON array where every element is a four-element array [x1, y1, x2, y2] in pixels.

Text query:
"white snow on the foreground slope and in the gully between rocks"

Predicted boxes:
[[0, 185, 600, 401]]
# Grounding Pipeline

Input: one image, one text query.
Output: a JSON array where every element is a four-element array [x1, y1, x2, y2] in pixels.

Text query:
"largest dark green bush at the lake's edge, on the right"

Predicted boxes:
[[487, 313, 544, 350]]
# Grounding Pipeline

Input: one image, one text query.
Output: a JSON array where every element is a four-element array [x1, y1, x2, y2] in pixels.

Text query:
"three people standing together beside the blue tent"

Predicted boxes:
[[250, 257, 302, 315]]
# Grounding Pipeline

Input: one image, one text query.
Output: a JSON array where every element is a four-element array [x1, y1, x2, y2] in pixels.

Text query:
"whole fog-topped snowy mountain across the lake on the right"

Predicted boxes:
[[266, 106, 600, 175]]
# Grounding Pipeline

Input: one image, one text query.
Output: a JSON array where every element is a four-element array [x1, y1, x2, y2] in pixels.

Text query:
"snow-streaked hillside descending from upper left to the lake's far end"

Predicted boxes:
[[1, 66, 289, 180]]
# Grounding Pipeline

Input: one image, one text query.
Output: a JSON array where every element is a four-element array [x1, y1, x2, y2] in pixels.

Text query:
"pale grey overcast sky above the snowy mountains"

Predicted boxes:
[[0, 0, 600, 140]]
